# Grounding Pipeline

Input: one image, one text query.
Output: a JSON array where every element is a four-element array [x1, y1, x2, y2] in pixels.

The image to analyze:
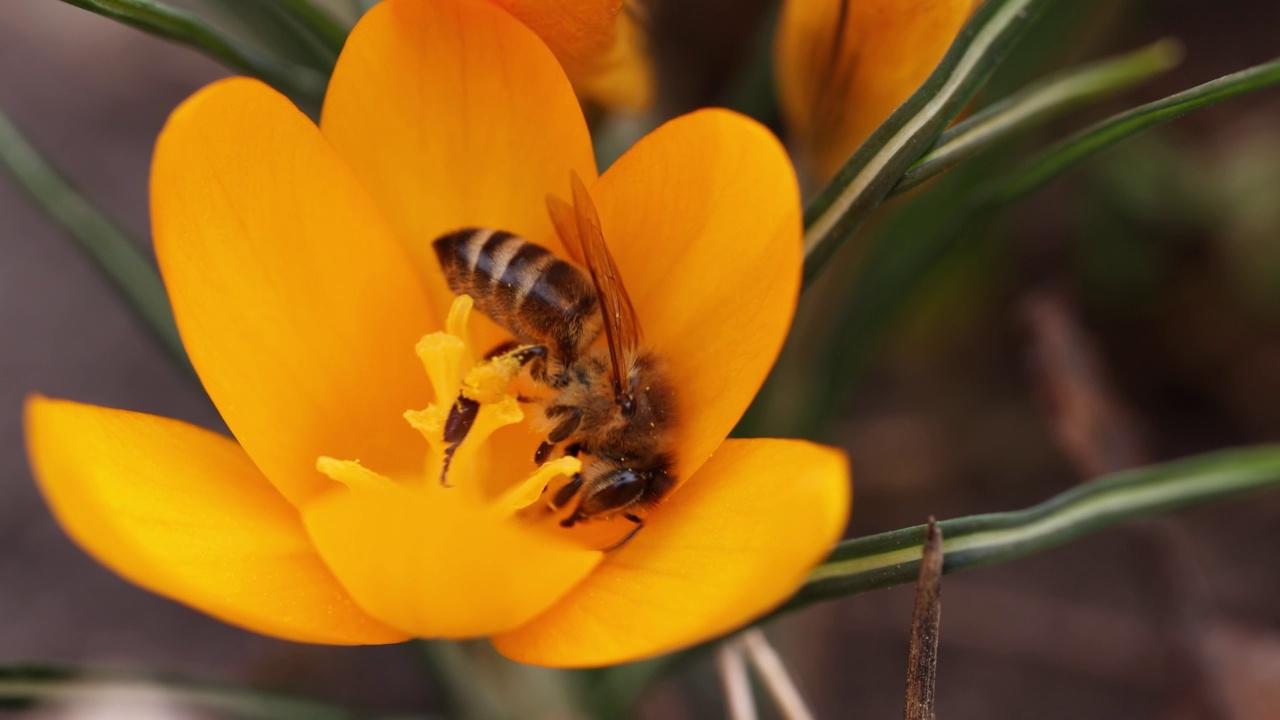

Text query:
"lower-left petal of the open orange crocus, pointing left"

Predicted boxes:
[[26, 397, 406, 644]]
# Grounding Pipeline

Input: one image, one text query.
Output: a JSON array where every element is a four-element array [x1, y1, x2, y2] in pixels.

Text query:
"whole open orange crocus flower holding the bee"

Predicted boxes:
[[27, 0, 850, 666]]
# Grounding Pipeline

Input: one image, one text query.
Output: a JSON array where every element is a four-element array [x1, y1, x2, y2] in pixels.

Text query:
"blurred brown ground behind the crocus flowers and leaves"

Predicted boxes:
[[0, 0, 1280, 719]]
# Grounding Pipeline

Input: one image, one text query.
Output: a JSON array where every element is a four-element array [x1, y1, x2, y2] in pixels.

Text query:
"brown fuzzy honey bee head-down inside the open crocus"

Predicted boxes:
[[433, 174, 676, 550]]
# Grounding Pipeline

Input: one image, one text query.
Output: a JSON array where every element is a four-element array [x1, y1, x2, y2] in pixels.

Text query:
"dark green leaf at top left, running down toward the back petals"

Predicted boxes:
[[63, 0, 328, 113]]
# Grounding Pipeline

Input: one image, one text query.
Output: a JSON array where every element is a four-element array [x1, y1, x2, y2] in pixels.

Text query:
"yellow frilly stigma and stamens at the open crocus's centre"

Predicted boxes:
[[316, 295, 582, 516]]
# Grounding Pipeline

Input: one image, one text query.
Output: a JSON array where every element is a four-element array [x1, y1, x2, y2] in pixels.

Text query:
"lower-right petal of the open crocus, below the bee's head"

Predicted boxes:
[[493, 439, 850, 667]]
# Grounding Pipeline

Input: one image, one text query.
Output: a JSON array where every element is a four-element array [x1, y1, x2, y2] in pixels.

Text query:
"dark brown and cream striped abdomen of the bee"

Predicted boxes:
[[433, 228, 602, 361]]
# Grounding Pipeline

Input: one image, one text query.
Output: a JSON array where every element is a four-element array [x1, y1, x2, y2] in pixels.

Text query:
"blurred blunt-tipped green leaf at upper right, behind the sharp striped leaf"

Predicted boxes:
[[892, 40, 1183, 195]]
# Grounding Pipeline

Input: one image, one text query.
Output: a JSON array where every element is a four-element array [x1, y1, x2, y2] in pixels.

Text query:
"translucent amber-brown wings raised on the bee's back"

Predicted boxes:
[[547, 173, 640, 393]]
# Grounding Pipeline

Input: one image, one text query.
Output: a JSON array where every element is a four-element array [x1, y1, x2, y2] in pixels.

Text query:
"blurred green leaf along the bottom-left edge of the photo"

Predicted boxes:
[[0, 664, 366, 720]]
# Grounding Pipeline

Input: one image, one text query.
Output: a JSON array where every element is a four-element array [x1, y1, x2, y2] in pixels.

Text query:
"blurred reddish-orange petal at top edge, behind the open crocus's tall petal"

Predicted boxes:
[[494, 0, 653, 110]]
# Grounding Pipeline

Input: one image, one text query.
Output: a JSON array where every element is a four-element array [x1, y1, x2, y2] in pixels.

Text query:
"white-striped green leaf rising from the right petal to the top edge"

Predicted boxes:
[[804, 0, 1050, 286]]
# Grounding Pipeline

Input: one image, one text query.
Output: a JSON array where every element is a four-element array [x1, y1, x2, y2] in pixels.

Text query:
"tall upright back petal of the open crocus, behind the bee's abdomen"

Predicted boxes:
[[321, 0, 595, 342]]
